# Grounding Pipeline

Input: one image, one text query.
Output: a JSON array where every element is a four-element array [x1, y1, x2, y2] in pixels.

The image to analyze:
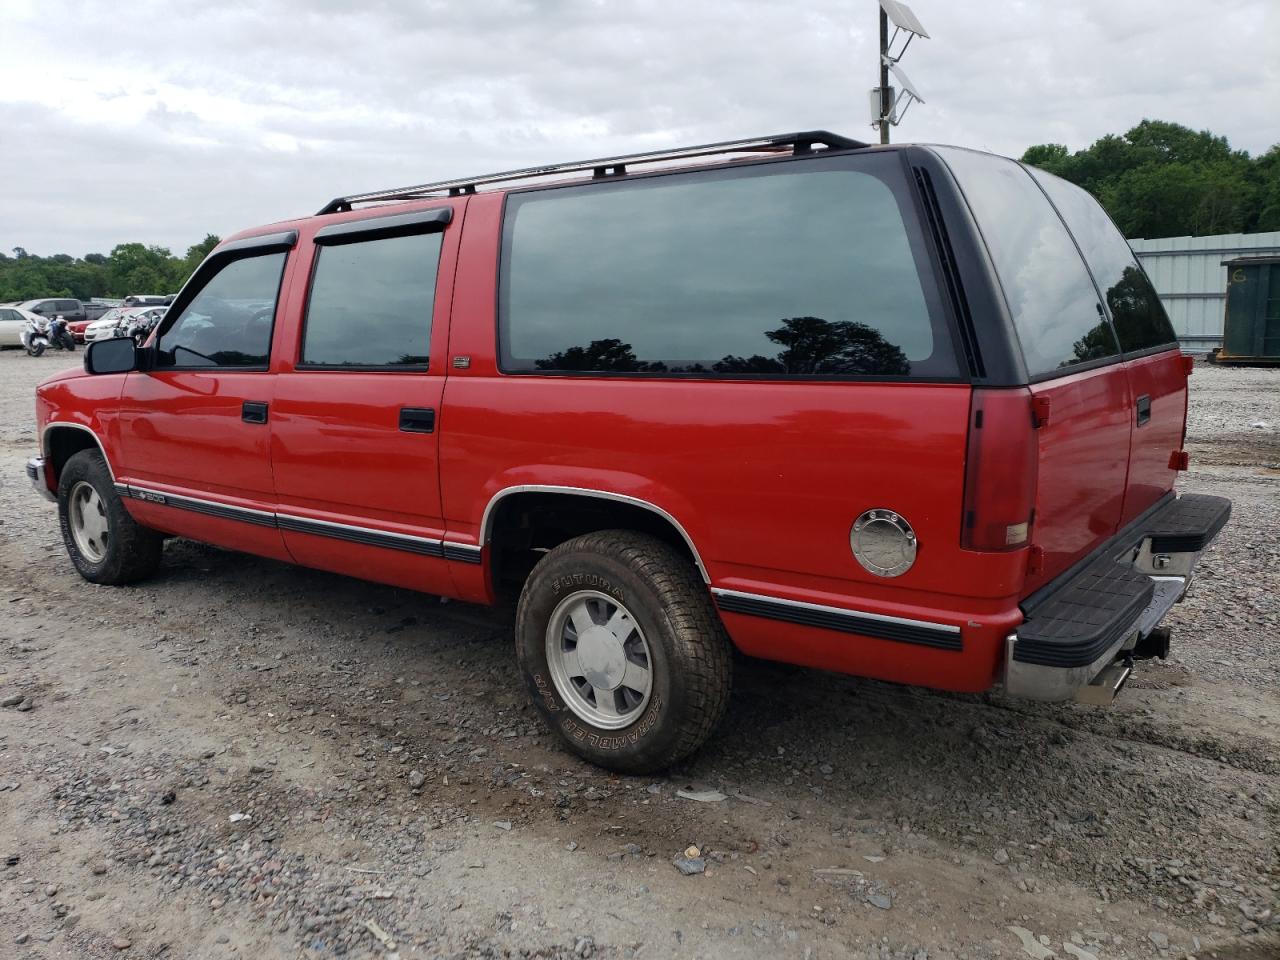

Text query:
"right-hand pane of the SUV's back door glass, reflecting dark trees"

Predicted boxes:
[[1032, 169, 1178, 353]]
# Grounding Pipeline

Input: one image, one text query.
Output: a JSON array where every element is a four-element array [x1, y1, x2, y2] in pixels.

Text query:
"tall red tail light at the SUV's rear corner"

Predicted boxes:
[[960, 389, 1039, 550]]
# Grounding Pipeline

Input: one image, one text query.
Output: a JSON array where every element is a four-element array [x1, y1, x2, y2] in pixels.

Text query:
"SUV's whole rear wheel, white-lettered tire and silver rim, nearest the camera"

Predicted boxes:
[[516, 530, 732, 773]]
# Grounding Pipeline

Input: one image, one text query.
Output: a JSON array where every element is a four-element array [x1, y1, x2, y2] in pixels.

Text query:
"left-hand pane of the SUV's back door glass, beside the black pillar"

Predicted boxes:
[[937, 147, 1120, 378]]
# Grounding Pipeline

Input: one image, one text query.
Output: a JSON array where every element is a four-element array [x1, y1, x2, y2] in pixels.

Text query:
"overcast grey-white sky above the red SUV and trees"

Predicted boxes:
[[0, 0, 1280, 256]]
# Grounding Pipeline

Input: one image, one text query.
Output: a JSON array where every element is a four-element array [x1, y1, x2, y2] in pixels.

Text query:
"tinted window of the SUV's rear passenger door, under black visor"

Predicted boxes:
[[302, 233, 442, 367]]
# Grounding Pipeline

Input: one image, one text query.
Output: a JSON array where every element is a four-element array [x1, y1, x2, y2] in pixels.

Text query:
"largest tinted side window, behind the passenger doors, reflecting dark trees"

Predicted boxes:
[[499, 155, 956, 376]]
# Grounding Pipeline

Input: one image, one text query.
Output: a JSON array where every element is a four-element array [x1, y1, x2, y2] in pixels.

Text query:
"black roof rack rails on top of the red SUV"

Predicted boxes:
[[316, 131, 867, 216]]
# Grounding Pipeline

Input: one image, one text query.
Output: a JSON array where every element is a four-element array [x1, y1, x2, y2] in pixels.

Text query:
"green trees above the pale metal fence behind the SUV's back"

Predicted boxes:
[[1023, 120, 1280, 238]]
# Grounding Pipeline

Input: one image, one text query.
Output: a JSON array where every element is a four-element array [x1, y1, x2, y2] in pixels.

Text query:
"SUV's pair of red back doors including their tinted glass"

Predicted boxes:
[[937, 148, 1187, 595]]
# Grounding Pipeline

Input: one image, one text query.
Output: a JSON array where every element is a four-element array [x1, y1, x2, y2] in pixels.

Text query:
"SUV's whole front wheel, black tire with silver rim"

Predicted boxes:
[[58, 449, 164, 585]]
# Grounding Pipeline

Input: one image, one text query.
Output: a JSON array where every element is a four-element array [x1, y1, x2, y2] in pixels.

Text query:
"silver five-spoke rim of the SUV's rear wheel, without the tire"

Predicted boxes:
[[547, 590, 653, 730]]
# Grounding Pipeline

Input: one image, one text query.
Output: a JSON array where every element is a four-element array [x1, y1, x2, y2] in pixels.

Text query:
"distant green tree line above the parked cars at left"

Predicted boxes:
[[0, 233, 219, 303]]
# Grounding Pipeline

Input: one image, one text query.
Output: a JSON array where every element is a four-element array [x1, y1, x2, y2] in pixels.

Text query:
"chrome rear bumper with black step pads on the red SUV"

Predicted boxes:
[[1005, 494, 1231, 703]]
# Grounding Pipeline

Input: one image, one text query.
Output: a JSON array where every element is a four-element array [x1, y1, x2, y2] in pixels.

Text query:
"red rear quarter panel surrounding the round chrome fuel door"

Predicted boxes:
[[440, 195, 1027, 690]]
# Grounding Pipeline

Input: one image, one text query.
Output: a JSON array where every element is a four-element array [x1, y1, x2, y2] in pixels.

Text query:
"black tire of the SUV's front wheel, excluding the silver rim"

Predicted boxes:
[[58, 449, 164, 586]]
